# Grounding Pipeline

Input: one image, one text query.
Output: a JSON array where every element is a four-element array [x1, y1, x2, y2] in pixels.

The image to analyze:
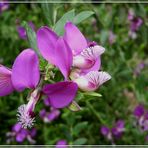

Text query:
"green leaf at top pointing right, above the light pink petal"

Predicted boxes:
[[73, 11, 94, 24]]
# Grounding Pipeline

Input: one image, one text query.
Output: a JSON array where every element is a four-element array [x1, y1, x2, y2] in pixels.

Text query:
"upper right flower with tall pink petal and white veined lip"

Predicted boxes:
[[64, 22, 105, 72]]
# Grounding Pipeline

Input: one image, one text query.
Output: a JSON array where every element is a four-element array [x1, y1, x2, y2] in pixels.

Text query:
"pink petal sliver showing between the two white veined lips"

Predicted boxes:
[[82, 57, 101, 74]]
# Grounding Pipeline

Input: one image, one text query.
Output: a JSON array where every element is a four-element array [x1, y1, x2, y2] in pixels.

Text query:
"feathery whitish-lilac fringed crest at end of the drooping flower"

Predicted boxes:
[[17, 104, 35, 128]]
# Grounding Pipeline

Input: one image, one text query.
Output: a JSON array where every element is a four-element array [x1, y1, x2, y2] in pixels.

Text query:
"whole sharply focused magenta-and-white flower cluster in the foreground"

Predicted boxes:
[[0, 22, 111, 128]]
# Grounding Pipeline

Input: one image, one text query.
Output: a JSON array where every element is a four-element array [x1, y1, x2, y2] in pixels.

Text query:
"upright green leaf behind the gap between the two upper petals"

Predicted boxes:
[[54, 9, 75, 35]]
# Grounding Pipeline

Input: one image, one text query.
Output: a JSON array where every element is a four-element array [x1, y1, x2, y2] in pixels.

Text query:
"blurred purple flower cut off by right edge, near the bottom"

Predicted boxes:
[[133, 105, 148, 132]]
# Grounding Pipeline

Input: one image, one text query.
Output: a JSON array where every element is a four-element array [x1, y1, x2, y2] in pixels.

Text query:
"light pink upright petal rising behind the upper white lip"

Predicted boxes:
[[64, 22, 87, 55]]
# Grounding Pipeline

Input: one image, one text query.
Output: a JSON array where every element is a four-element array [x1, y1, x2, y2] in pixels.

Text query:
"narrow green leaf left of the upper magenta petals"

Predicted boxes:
[[22, 21, 39, 54]]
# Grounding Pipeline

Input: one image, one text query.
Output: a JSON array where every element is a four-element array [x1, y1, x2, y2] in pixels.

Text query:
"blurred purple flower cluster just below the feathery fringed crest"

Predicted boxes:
[[6, 123, 36, 144]]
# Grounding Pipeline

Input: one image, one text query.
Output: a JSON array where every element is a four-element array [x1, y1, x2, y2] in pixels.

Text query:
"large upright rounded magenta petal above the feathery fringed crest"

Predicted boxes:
[[12, 49, 40, 91]]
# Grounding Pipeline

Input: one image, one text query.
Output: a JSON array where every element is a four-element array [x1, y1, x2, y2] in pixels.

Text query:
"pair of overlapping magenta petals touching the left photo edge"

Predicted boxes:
[[0, 49, 40, 96]]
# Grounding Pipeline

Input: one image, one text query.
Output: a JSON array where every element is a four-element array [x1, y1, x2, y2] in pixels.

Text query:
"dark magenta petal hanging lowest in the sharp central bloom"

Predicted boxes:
[[43, 81, 78, 108]]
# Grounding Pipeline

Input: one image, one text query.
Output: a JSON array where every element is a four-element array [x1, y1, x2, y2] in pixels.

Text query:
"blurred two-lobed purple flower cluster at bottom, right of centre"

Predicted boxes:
[[101, 120, 125, 144]]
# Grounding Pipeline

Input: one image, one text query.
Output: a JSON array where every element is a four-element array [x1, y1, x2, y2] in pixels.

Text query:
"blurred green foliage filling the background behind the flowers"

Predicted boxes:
[[0, 0, 148, 145]]
